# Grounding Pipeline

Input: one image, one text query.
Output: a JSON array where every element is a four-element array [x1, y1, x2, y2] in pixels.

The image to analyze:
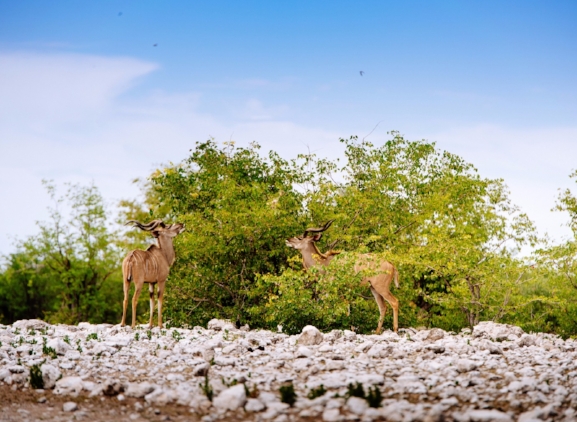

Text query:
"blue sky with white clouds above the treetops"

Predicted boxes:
[[0, 1, 577, 253]]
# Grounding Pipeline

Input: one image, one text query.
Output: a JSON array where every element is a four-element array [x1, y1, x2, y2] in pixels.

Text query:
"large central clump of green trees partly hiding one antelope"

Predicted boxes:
[[119, 132, 535, 333]]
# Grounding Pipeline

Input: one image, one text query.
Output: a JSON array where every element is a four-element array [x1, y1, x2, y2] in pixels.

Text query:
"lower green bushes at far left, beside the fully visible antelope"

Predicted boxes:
[[0, 182, 122, 324]]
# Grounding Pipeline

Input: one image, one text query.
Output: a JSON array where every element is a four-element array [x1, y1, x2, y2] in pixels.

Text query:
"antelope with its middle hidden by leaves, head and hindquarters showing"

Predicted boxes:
[[286, 220, 399, 334]]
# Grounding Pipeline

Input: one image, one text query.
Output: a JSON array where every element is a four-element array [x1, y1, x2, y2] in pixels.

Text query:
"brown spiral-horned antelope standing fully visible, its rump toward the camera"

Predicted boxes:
[[120, 220, 184, 328]]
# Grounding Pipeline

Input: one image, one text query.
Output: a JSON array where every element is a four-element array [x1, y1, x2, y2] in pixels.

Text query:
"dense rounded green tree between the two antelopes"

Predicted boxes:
[[131, 141, 303, 325]]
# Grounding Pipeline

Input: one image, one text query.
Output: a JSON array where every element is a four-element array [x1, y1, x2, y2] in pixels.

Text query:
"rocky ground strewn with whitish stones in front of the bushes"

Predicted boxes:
[[0, 320, 577, 422]]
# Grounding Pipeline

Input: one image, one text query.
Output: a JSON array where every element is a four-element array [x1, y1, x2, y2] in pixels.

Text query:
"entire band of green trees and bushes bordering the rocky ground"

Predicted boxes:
[[0, 133, 577, 335]]
